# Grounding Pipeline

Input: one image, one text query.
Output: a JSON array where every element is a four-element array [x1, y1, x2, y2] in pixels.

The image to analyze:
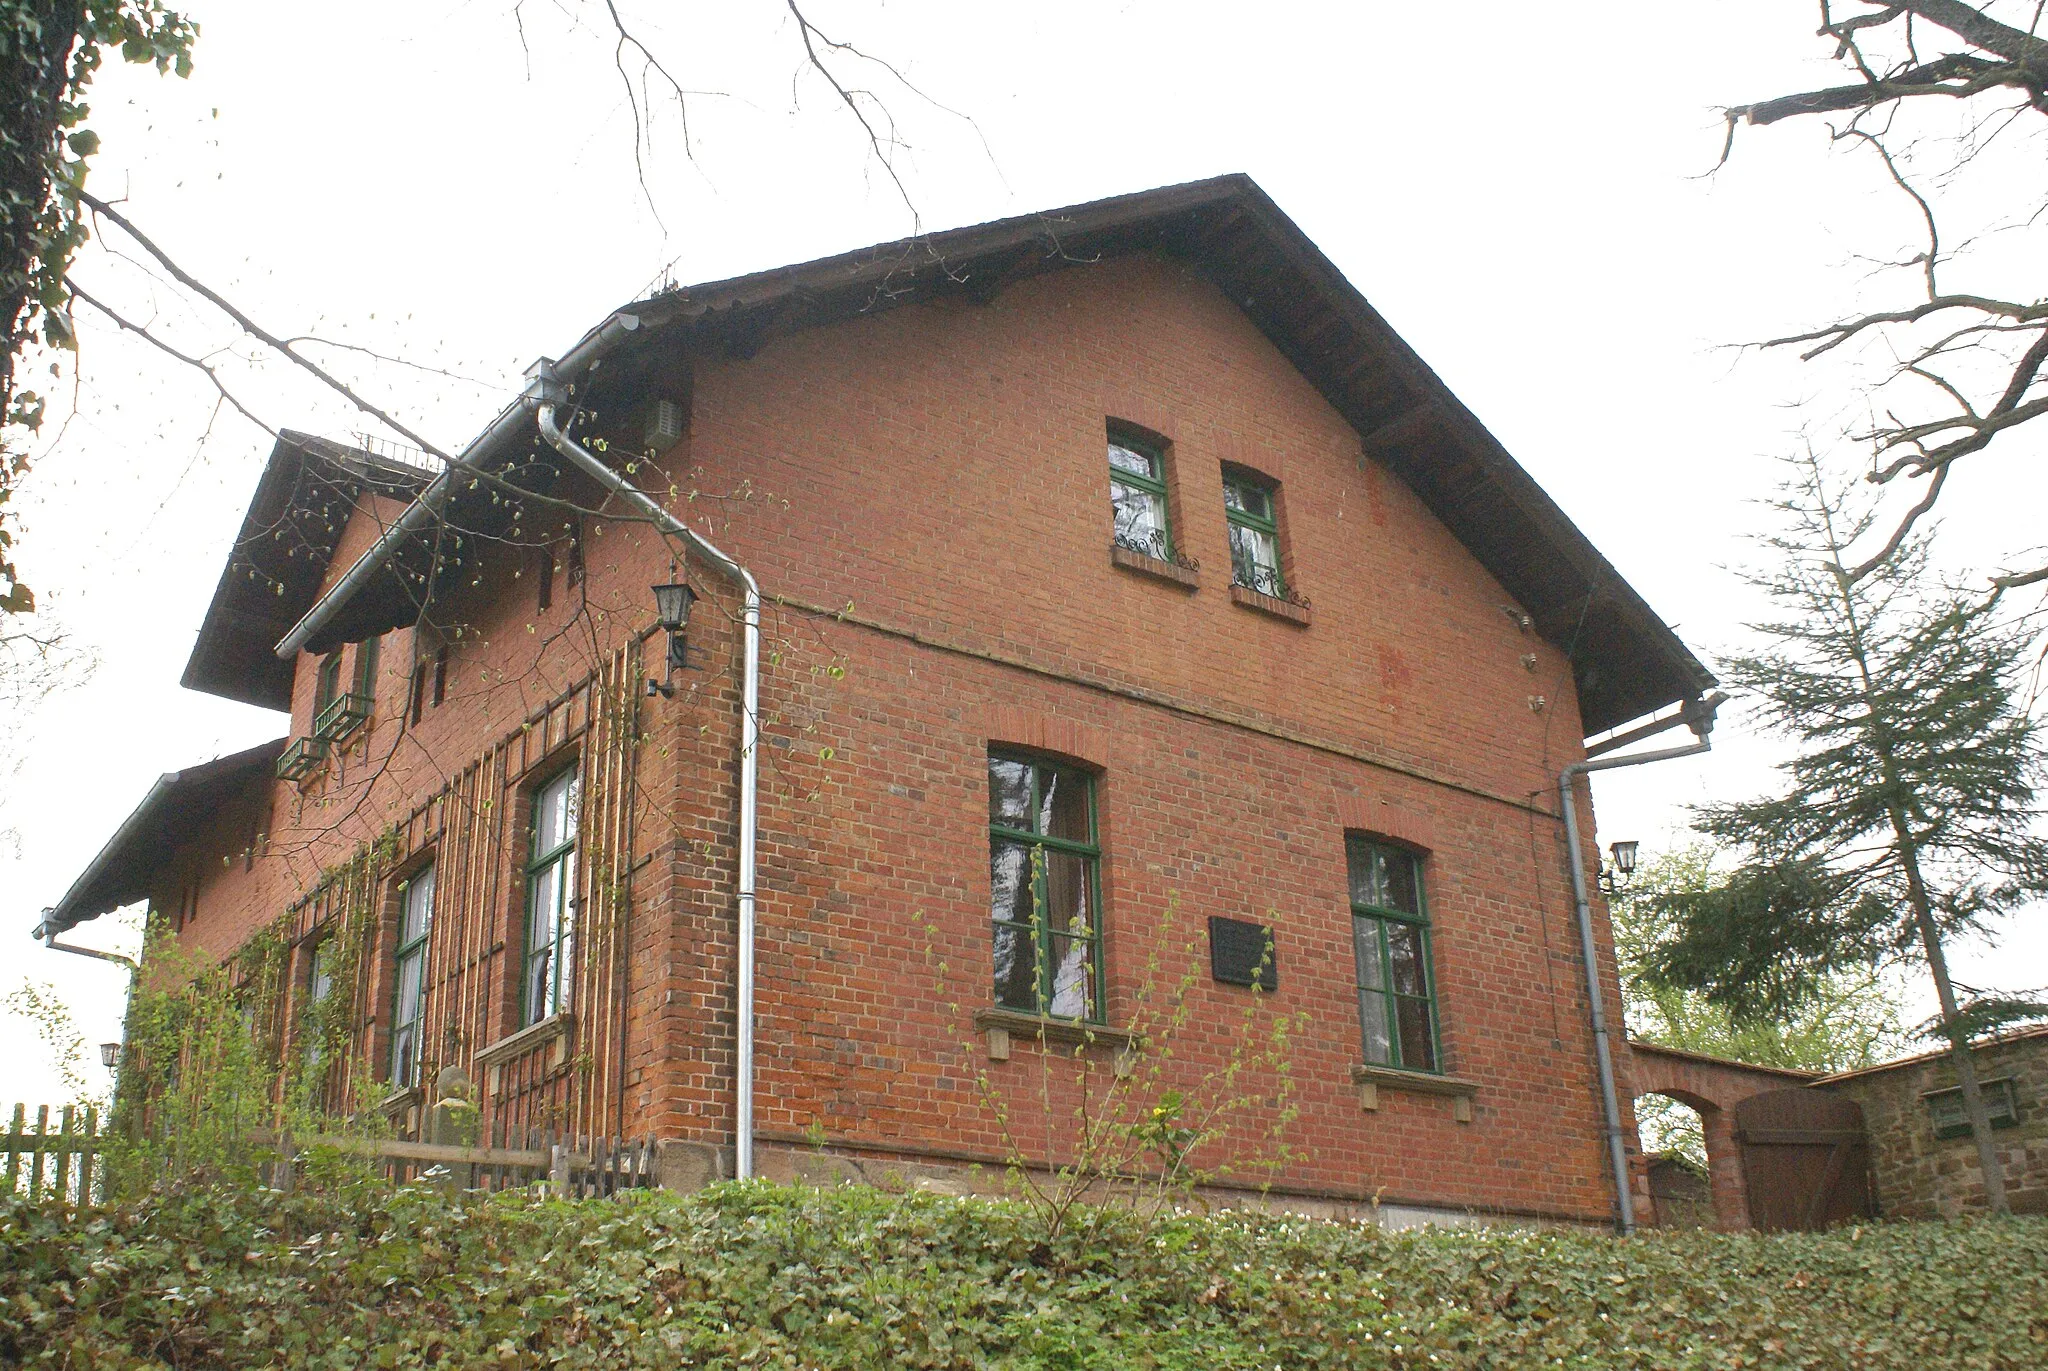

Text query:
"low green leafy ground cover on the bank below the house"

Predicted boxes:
[[0, 1185, 2048, 1371]]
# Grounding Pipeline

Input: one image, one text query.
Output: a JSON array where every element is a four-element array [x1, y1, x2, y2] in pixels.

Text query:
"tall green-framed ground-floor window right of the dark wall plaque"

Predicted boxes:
[[1343, 834, 1442, 1072]]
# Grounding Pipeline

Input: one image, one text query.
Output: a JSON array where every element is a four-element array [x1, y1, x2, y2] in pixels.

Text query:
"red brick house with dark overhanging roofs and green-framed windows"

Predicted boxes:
[[41, 176, 1712, 1221]]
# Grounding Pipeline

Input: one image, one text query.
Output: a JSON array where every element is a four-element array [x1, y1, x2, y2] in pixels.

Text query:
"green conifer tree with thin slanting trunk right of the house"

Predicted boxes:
[[1649, 457, 2048, 1213]]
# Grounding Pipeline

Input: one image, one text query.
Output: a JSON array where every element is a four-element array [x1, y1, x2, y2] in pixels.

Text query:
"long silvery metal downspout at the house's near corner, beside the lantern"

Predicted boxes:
[[528, 401, 762, 1180]]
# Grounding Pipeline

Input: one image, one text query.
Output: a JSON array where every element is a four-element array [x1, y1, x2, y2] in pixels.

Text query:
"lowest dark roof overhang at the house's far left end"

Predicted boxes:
[[37, 738, 285, 937]]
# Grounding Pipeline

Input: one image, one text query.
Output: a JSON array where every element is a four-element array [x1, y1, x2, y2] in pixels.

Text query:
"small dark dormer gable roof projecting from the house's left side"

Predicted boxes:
[[178, 428, 428, 711]]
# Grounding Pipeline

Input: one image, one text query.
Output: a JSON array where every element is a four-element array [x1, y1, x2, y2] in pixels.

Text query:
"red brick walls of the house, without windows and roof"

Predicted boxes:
[[140, 245, 1626, 1221]]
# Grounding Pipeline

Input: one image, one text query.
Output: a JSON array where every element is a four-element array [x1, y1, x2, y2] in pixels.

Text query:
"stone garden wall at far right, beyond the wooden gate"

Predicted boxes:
[[1819, 1027, 2048, 1219]]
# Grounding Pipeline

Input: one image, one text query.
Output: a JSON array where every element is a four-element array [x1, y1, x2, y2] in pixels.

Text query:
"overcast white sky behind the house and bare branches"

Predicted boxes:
[[0, 0, 2048, 1103]]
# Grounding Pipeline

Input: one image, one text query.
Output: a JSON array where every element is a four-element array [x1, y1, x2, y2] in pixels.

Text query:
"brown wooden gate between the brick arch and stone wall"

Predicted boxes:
[[1735, 1090, 1874, 1232]]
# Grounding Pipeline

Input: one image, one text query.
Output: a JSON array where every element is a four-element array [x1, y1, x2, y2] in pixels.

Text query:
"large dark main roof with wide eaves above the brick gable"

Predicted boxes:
[[281, 176, 1714, 734]]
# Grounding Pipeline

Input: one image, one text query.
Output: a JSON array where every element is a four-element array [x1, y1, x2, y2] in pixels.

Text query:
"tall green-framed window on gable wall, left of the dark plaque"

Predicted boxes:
[[989, 752, 1102, 1023]]
